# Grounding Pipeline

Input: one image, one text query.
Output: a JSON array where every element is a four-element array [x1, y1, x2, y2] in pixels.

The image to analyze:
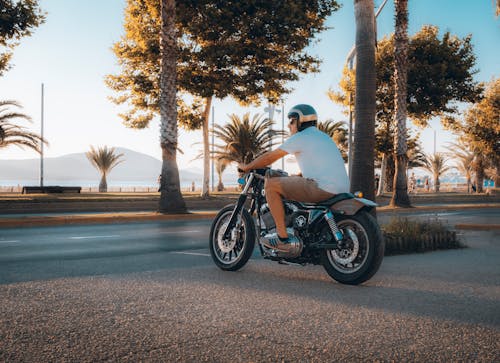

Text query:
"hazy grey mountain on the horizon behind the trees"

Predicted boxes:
[[0, 148, 236, 186]]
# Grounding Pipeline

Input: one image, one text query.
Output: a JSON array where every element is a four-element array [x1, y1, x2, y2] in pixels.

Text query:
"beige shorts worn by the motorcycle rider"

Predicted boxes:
[[265, 176, 335, 203]]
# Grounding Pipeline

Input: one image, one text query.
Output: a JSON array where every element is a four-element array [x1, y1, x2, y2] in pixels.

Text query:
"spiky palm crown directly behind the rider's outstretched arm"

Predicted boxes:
[[213, 113, 283, 164]]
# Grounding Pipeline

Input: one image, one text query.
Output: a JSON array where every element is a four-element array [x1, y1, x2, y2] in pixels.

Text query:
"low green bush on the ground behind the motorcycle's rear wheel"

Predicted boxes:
[[382, 217, 466, 255]]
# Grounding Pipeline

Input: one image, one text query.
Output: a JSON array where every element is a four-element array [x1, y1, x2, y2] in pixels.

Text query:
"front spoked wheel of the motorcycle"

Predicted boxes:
[[210, 206, 255, 271]]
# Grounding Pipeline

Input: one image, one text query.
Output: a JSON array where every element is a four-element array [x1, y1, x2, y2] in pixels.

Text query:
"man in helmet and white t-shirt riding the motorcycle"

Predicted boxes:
[[239, 104, 349, 251]]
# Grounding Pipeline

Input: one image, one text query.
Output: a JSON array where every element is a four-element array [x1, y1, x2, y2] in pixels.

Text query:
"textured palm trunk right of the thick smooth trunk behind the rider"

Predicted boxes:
[[390, 0, 411, 207]]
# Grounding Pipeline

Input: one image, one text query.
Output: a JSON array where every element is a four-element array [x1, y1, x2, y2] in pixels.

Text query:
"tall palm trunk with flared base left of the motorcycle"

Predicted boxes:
[[159, 0, 186, 213]]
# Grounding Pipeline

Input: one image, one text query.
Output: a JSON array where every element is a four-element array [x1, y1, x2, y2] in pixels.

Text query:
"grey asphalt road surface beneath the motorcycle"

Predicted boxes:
[[0, 210, 500, 362]]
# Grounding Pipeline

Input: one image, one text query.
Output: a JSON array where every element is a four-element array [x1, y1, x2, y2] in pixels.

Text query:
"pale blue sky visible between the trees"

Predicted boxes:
[[0, 0, 500, 176]]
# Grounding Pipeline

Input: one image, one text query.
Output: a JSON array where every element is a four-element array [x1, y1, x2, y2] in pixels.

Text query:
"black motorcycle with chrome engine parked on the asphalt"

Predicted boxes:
[[209, 168, 385, 285]]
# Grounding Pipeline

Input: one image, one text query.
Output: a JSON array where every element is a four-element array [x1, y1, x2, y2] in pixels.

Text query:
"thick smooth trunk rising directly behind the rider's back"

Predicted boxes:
[[351, 0, 376, 200]]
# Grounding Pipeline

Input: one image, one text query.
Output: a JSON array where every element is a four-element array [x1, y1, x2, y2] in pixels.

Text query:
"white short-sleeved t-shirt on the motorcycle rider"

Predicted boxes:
[[279, 127, 349, 194]]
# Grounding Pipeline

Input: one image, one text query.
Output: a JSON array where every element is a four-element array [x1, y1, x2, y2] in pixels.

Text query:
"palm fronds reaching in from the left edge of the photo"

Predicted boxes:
[[0, 100, 47, 153]]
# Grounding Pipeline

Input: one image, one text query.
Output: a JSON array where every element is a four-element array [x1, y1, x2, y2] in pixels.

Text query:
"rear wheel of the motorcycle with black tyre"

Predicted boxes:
[[322, 211, 385, 285]]
